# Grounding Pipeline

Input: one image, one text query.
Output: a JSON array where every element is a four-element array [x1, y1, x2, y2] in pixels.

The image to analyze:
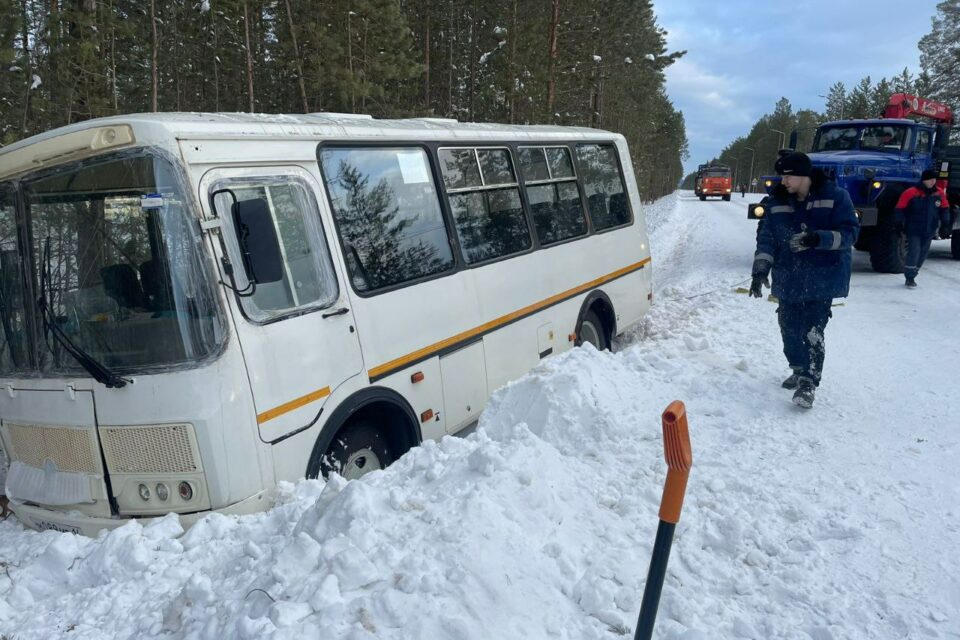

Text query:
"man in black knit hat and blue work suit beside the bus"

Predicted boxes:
[[750, 152, 860, 409]]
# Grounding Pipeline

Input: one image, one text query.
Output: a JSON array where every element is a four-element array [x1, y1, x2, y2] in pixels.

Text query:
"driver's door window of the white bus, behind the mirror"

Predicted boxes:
[[212, 177, 339, 322]]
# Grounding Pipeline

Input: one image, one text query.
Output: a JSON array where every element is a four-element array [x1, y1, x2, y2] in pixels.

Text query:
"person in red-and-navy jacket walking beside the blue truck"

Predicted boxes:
[[895, 169, 950, 288]]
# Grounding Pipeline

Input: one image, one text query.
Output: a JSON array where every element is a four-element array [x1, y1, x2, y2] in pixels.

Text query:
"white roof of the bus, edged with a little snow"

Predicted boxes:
[[0, 112, 622, 178]]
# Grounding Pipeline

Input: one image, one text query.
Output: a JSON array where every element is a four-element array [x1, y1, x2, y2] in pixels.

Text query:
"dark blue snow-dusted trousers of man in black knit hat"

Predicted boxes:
[[777, 298, 833, 386]]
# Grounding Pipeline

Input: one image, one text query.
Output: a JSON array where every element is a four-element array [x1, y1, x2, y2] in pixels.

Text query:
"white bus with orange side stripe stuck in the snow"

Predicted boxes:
[[0, 114, 652, 535]]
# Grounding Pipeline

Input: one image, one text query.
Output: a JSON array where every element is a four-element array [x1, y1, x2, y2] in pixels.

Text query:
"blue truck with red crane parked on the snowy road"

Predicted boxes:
[[748, 93, 960, 273]]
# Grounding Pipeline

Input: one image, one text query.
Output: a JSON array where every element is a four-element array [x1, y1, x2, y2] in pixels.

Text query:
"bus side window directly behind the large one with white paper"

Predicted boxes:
[[438, 148, 533, 264]]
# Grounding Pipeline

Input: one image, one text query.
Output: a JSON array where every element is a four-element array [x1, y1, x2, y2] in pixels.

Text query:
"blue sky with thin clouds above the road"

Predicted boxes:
[[654, 0, 937, 171]]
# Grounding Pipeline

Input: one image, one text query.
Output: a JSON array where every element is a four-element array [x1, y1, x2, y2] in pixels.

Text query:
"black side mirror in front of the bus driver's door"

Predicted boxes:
[[231, 198, 283, 284]]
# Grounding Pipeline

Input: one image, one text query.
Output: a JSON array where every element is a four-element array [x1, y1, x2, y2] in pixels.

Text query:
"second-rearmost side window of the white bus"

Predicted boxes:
[[519, 147, 587, 245]]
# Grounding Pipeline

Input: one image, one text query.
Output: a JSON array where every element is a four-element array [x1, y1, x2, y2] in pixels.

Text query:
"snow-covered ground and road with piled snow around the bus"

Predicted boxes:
[[0, 192, 960, 640]]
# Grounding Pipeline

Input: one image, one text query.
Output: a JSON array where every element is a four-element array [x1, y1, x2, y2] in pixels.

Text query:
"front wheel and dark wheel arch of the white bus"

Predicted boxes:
[[306, 387, 421, 478]]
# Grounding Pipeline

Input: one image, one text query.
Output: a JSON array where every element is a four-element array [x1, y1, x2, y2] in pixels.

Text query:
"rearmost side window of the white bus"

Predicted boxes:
[[577, 144, 630, 231]]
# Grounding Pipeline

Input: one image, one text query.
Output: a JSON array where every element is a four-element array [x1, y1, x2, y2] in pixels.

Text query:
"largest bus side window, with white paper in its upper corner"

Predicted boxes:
[[320, 147, 456, 292]]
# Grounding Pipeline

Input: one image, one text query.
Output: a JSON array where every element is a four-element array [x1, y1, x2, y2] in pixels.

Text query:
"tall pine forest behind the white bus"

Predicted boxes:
[[0, 0, 687, 200]]
